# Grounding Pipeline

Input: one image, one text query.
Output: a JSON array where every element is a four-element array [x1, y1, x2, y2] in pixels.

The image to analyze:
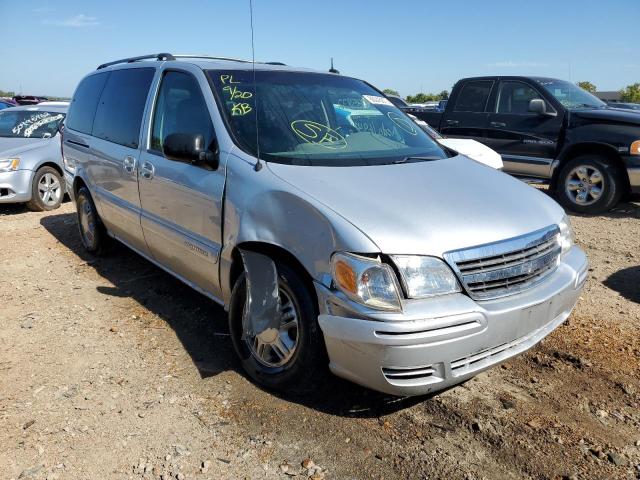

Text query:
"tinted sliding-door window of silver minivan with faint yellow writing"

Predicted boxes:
[[93, 68, 155, 148]]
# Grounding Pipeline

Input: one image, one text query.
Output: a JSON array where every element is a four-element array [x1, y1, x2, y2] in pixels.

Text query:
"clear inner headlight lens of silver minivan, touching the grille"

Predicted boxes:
[[391, 255, 460, 298]]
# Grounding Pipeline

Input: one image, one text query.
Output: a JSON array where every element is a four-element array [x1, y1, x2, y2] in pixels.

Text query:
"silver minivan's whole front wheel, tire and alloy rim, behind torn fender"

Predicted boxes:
[[229, 262, 326, 393]]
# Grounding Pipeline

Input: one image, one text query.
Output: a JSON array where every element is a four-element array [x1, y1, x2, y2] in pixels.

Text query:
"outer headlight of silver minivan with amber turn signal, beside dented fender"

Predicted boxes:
[[331, 253, 401, 311]]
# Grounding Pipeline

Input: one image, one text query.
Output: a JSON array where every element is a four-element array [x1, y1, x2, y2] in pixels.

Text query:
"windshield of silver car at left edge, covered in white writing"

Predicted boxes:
[[0, 109, 64, 138]]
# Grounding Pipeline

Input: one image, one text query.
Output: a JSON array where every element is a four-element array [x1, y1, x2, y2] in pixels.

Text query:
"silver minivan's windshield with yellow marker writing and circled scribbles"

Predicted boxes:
[[207, 70, 448, 166]]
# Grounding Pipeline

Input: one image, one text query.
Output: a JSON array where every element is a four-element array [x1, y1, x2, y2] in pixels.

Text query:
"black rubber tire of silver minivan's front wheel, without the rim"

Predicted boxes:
[[229, 262, 327, 394]]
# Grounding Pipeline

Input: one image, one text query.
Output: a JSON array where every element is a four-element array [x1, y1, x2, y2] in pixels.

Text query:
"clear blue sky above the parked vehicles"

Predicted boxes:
[[0, 0, 640, 96]]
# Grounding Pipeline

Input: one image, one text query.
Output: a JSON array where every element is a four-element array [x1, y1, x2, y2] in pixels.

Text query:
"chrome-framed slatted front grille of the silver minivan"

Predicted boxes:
[[444, 225, 561, 300]]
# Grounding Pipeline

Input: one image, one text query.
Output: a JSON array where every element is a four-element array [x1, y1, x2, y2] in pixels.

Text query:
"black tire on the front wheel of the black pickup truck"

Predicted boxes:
[[556, 154, 624, 214]]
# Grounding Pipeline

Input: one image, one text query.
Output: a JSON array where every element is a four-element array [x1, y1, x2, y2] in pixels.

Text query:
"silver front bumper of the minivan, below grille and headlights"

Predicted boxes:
[[316, 247, 588, 396]]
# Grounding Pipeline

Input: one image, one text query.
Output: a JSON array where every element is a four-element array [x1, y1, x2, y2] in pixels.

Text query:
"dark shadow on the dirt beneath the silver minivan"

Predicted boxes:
[[40, 213, 426, 418]]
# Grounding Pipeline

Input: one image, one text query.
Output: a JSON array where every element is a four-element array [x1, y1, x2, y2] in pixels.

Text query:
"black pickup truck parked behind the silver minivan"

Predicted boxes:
[[411, 77, 640, 213]]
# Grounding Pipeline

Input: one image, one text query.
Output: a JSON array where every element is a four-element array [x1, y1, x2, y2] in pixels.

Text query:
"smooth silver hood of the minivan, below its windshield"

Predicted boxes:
[[268, 155, 564, 256]]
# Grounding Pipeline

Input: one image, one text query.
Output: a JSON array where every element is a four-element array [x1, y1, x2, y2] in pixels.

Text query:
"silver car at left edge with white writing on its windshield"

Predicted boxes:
[[0, 105, 67, 211]]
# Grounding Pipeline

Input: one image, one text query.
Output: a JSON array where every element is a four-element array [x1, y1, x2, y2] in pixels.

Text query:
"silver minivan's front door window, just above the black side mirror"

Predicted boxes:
[[150, 70, 215, 152]]
